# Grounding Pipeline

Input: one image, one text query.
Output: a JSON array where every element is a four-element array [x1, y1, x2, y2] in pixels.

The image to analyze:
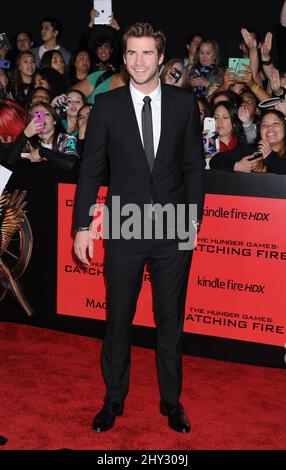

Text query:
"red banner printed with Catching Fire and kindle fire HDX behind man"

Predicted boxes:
[[57, 184, 286, 346]]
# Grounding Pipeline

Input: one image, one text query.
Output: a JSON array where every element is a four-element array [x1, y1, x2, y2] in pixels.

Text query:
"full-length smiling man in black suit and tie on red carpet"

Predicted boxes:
[[74, 23, 204, 432]]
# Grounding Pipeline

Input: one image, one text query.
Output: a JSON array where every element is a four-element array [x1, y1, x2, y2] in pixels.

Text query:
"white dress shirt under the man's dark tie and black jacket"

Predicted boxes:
[[130, 82, 161, 157]]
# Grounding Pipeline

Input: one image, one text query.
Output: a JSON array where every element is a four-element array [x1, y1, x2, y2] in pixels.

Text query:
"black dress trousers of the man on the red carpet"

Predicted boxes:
[[102, 240, 192, 404]]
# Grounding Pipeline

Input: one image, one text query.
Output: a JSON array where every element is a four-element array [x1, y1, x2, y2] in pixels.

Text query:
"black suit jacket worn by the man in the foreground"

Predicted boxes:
[[73, 84, 205, 229]]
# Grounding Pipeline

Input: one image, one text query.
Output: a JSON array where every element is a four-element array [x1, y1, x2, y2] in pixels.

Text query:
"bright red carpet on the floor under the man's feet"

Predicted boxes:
[[0, 323, 286, 450]]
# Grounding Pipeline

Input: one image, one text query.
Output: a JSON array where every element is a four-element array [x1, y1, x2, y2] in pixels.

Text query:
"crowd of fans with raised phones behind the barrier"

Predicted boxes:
[[0, 1, 286, 174]]
